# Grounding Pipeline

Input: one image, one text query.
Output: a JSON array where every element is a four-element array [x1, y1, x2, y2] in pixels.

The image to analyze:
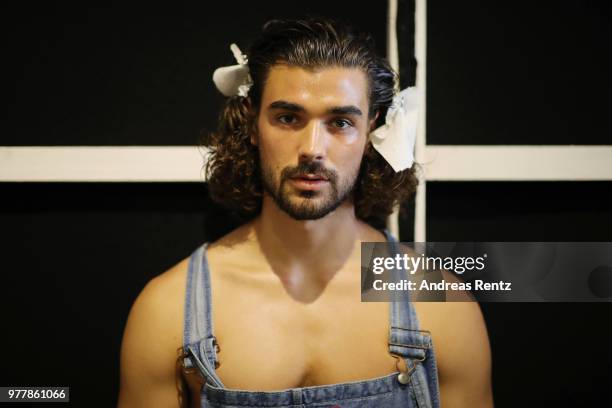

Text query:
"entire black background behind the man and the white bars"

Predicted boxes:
[[0, 0, 612, 407]]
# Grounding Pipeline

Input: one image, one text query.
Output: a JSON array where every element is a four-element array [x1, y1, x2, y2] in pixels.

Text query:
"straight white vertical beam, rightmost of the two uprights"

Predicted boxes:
[[414, 0, 427, 242]]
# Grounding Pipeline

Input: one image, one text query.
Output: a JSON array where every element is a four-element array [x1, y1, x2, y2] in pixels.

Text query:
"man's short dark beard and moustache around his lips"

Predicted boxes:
[[261, 161, 357, 221]]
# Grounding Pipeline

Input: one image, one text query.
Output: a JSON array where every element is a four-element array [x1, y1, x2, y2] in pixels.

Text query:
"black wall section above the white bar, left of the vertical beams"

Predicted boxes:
[[5, 0, 387, 146]]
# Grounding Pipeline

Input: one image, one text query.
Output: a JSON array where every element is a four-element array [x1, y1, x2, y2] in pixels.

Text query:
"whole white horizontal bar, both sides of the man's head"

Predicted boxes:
[[0, 145, 612, 182]]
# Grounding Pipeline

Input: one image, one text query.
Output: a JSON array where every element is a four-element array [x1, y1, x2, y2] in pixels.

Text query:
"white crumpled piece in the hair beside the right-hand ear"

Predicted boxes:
[[370, 87, 418, 172]]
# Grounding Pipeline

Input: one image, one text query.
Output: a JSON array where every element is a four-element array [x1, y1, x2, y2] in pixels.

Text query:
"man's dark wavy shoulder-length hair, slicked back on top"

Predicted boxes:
[[203, 17, 418, 224]]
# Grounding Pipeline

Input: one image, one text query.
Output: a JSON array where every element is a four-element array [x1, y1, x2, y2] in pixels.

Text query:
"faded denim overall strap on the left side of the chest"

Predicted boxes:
[[183, 243, 223, 387]]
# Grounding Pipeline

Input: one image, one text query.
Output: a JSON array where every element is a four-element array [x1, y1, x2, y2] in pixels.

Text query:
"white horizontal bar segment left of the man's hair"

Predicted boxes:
[[0, 146, 206, 182]]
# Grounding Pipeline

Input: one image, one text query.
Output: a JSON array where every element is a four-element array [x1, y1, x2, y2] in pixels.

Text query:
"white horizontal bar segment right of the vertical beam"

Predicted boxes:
[[422, 145, 612, 181]]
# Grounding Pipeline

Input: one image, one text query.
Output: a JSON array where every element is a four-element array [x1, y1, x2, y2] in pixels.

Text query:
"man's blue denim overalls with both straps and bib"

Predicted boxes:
[[183, 230, 440, 408]]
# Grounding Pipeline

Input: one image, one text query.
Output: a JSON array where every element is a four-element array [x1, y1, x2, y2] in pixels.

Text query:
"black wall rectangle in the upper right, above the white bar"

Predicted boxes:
[[427, 0, 612, 144]]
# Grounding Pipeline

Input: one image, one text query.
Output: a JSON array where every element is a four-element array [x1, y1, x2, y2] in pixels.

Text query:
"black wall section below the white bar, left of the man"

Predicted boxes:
[[0, 183, 237, 407]]
